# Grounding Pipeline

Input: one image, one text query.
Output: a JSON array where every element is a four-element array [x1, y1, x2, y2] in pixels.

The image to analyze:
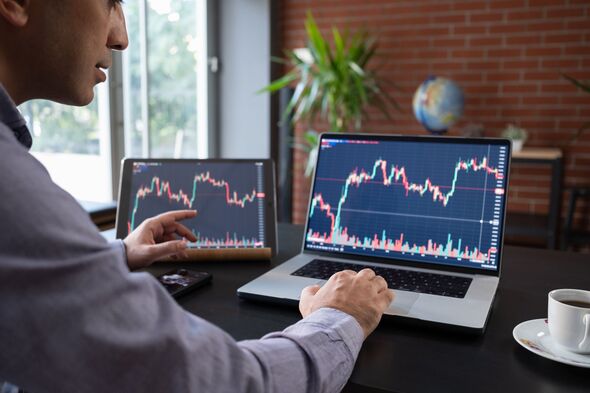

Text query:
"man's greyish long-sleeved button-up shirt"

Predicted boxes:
[[0, 85, 363, 393]]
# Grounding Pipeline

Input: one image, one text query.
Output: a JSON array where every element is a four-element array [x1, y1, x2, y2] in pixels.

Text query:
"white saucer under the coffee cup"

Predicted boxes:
[[512, 318, 590, 368]]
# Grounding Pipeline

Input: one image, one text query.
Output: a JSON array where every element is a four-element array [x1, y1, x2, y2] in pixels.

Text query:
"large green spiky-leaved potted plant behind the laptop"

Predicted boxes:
[[261, 12, 399, 176]]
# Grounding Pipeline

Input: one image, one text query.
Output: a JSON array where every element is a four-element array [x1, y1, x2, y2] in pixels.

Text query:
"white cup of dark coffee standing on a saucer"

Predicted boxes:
[[547, 289, 590, 354]]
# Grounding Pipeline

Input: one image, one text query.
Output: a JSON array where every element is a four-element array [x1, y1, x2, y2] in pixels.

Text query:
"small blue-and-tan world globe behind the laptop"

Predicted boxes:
[[412, 76, 464, 134]]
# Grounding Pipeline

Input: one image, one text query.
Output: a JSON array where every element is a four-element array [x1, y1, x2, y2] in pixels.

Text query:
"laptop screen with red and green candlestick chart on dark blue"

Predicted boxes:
[[304, 134, 510, 270]]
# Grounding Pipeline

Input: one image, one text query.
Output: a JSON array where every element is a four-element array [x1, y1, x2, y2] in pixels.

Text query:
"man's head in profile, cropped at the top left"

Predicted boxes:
[[0, 0, 127, 105]]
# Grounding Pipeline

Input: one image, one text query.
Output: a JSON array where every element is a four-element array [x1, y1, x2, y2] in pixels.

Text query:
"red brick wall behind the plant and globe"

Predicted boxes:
[[281, 0, 590, 236]]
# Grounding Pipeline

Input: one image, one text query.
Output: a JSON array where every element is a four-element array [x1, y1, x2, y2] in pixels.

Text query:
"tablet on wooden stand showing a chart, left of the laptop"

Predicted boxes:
[[116, 158, 277, 260]]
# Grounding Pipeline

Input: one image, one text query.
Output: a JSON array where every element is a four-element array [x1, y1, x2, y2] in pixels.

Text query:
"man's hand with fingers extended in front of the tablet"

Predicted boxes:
[[123, 210, 197, 270]]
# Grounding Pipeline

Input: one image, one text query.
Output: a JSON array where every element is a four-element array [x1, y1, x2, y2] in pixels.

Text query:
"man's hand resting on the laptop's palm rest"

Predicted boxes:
[[299, 269, 394, 338]]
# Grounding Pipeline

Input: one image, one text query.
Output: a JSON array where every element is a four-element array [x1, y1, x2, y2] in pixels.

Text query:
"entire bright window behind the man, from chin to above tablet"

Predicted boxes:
[[20, 0, 216, 202]]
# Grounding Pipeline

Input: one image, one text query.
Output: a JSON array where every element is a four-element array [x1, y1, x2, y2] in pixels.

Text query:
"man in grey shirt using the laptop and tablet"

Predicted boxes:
[[0, 0, 393, 393]]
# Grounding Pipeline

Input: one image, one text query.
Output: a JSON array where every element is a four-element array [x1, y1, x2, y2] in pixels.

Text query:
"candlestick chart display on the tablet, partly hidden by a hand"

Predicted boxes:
[[127, 162, 266, 248]]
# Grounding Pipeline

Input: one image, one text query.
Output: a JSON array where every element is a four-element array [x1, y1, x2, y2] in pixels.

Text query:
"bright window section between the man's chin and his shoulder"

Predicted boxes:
[[19, 85, 113, 202]]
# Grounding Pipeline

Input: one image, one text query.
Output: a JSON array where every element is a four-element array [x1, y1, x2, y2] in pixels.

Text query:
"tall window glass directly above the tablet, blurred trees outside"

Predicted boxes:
[[123, 0, 197, 157]]
